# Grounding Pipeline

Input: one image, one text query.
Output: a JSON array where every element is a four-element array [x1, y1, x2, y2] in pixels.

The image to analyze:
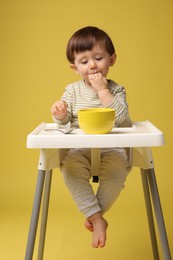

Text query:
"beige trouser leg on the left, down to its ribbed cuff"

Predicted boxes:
[[61, 149, 101, 217]]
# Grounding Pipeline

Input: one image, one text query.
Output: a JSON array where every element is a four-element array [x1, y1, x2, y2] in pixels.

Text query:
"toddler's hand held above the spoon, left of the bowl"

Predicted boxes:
[[51, 100, 68, 120]]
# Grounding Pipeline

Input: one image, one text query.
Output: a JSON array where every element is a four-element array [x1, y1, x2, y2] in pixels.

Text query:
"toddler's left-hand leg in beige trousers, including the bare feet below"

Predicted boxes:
[[61, 150, 108, 248]]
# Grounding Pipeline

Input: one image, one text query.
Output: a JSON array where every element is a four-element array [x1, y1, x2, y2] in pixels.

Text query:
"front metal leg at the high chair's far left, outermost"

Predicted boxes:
[[25, 170, 45, 260]]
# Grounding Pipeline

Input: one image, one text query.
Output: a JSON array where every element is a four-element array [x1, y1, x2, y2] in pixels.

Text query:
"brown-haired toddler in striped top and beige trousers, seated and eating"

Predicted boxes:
[[51, 26, 129, 248]]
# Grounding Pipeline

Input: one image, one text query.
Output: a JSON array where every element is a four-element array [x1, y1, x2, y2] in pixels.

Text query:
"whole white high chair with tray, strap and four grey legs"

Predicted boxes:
[[25, 121, 171, 260]]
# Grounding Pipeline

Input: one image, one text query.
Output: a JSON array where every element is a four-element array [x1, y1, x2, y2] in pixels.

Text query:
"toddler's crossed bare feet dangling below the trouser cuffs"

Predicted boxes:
[[85, 212, 108, 248]]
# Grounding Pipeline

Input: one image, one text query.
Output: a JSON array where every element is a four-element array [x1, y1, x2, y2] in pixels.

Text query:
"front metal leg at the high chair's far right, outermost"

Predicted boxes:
[[147, 169, 171, 260]]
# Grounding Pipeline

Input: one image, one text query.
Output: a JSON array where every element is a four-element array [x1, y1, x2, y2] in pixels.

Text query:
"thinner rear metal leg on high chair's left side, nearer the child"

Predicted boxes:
[[37, 170, 52, 260]]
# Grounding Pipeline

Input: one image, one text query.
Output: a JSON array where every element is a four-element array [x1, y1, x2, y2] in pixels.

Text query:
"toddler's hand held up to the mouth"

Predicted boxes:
[[88, 72, 108, 92]]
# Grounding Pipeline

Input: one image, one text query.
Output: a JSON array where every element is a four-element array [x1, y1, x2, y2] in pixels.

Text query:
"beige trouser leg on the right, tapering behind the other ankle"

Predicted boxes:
[[96, 151, 128, 212]]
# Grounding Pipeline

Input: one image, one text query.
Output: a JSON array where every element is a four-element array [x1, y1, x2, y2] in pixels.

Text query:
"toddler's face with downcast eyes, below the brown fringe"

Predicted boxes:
[[71, 43, 116, 85]]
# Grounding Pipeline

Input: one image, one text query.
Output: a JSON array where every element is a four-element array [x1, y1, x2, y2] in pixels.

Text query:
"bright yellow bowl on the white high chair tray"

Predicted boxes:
[[78, 108, 115, 134]]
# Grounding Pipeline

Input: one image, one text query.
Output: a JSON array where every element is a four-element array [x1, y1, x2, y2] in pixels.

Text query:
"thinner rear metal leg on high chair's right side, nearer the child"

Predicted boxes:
[[141, 169, 159, 260]]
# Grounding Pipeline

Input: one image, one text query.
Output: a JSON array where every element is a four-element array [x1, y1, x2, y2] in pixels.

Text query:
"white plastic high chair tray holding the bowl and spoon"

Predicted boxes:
[[27, 121, 164, 149]]
